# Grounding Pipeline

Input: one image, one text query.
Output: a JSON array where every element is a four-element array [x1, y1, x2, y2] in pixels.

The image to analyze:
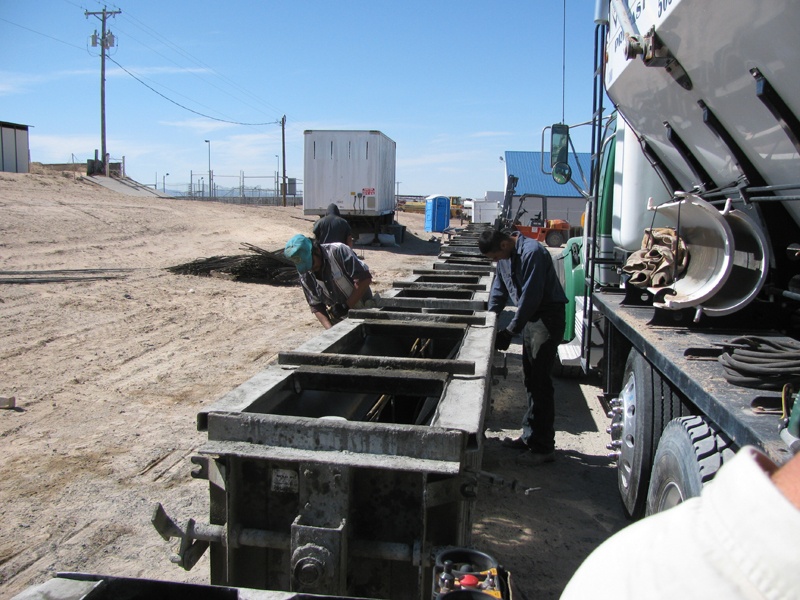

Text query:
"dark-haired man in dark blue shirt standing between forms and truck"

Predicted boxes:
[[478, 229, 567, 465]]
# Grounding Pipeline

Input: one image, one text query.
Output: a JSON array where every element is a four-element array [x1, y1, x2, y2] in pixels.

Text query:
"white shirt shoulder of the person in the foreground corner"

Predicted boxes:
[[561, 447, 800, 600]]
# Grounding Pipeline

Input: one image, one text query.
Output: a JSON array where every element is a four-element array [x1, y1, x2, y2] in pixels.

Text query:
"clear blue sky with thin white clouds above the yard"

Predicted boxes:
[[0, 0, 594, 198]]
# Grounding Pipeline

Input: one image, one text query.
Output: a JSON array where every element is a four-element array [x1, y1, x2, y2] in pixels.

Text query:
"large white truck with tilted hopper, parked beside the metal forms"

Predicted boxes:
[[551, 0, 800, 518]]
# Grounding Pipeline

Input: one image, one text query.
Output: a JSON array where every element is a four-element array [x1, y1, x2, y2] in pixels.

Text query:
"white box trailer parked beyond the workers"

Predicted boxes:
[[303, 130, 396, 224]]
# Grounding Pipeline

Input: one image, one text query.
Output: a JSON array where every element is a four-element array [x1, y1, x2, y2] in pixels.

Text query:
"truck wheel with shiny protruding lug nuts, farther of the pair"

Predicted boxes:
[[611, 349, 683, 519]]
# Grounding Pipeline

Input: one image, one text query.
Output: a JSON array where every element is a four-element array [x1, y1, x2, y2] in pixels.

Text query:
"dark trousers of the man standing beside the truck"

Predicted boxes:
[[521, 305, 565, 454]]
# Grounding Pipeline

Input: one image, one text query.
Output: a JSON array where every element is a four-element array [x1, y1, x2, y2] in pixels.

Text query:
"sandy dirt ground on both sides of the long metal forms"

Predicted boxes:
[[0, 173, 625, 600]]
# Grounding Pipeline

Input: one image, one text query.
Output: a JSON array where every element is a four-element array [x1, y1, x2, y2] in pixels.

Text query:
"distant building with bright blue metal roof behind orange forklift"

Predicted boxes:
[[501, 150, 591, 227]]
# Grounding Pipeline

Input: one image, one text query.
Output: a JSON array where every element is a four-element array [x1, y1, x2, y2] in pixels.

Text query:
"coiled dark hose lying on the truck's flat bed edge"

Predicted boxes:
[[718, 336, 800, 390]]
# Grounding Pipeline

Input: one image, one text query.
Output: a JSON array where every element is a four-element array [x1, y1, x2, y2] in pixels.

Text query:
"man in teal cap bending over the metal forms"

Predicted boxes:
[[283, 234, 372, 329]]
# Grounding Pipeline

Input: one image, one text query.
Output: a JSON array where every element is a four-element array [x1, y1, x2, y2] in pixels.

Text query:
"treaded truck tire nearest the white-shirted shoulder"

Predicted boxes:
[[646, 416, 734, 516]]
